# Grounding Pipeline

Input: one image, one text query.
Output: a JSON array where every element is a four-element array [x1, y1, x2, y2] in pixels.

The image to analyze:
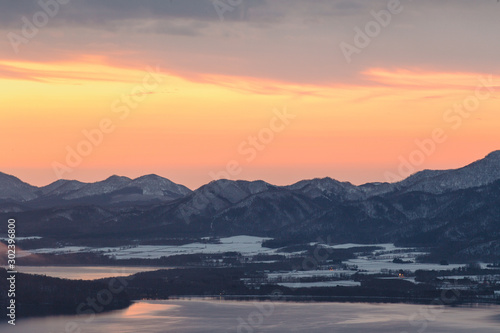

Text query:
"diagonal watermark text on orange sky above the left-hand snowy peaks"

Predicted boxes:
[[52, 66, 164, 179]]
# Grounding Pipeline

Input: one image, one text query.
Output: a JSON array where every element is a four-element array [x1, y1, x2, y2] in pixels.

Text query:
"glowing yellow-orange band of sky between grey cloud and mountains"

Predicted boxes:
[[0, 58, 500, 187]]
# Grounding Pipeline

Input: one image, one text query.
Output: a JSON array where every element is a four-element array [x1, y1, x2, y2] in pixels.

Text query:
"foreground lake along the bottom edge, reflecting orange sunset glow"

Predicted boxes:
[[0, 300, 500, 333]]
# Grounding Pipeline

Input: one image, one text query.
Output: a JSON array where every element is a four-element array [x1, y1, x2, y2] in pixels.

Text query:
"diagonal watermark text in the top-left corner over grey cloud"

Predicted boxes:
[[7, 0, 70, 54]]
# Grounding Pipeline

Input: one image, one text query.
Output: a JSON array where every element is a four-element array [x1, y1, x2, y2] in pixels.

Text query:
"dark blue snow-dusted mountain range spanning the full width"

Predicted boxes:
[[0, 151, 500, 260]]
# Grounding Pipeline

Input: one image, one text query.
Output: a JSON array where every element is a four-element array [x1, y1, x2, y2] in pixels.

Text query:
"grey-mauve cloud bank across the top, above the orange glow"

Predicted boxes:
[[0, 0, 500, 90]]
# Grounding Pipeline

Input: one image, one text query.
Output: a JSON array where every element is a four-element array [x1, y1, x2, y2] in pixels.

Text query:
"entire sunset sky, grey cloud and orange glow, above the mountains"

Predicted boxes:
[[0, 0, 500, 189]]
